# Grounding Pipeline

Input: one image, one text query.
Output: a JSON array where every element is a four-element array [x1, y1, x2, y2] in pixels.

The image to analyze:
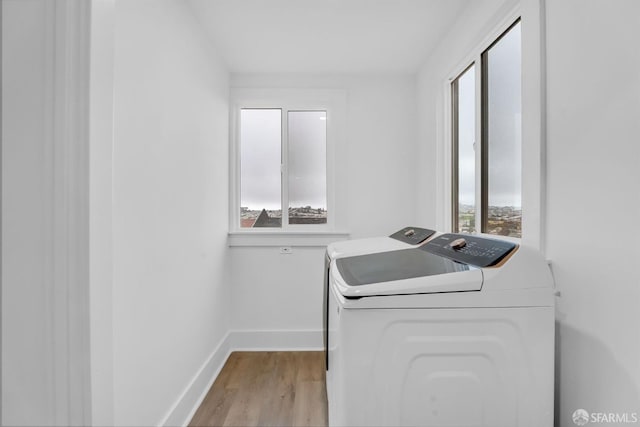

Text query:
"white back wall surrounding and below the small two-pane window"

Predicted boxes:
[[231, 75, 418, 342]]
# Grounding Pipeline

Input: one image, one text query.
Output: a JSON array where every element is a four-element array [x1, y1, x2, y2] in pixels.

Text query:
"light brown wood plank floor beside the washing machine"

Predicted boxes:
[[189, 351, 327, 426]]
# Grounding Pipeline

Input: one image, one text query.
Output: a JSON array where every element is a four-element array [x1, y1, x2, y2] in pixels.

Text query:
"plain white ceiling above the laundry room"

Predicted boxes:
[[189, 0, 473, 73]]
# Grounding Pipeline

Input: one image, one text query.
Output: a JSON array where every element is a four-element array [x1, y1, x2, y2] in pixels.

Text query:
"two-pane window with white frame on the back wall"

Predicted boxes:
[[231, 90, 341, 232]]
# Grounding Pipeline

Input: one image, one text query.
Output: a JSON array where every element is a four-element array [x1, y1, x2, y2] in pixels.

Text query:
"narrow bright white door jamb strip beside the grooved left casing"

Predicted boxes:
[[89, 0, 115, 426]]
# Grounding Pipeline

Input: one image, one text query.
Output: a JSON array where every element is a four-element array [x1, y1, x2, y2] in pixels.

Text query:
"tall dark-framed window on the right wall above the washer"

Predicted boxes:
[[451, 20, 522, 238]]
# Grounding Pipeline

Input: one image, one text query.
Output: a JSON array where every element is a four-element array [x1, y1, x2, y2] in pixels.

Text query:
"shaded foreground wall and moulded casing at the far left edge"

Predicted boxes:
[[2, 0, 91, 425]]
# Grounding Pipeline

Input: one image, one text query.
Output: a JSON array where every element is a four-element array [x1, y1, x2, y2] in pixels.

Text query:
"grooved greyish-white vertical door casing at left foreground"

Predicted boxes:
[[45, 0, 91, 425]]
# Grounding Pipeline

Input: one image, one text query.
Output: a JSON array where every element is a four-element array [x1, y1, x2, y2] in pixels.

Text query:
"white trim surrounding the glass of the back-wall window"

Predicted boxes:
[[229, 88, 346, 235]]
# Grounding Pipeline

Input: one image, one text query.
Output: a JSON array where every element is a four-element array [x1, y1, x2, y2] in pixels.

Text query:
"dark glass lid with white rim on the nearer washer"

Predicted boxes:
[[335, 248, 482, 297]]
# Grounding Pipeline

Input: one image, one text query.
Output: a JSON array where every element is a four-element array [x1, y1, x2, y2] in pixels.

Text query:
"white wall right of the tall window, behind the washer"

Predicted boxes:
[[546, 0, 640, 427]]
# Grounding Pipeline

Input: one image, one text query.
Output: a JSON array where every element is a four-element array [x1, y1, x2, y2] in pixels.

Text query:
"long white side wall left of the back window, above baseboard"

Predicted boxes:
[[113, 0, 230, 425]]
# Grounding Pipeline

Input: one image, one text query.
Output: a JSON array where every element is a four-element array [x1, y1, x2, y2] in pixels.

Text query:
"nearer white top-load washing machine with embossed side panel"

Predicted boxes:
[[326, 234, 554, 427]]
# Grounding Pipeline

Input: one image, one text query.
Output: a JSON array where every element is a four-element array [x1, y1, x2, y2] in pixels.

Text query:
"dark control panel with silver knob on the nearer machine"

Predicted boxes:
[[420, 234, 517, 267]]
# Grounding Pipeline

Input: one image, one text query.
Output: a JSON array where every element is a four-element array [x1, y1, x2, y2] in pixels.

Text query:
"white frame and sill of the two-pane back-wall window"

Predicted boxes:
[[229, 88, 346, 241]]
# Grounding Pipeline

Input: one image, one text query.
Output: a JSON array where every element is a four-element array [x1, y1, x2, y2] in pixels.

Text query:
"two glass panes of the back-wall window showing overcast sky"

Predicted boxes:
[[239, 108, 327, 228]]
